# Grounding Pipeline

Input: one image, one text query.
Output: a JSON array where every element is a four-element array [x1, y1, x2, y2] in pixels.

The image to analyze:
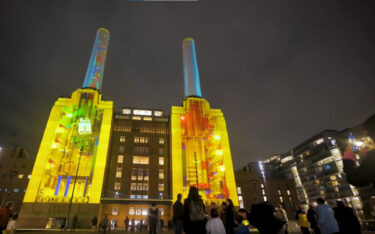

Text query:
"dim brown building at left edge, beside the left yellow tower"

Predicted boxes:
[[0, 144, 34, 213]]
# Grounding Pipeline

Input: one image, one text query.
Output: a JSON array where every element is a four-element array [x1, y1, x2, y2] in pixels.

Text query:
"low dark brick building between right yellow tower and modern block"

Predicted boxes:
[[235, 162, 299, 219]]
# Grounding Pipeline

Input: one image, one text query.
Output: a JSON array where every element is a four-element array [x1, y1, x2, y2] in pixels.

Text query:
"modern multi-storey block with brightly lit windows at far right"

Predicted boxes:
[[264, 126, 375, 219]]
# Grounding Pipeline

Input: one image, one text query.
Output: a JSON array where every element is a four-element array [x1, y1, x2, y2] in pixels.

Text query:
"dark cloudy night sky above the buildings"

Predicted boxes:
[[0, 0, 375, 167]]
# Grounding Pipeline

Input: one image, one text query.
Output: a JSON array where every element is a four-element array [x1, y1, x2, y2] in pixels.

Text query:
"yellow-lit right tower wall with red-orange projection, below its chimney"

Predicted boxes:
[[171, 97, 238, 206]]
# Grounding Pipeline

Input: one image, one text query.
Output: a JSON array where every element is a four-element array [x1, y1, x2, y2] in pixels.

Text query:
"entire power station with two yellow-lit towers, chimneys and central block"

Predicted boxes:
[[18, 28, 238, 228]]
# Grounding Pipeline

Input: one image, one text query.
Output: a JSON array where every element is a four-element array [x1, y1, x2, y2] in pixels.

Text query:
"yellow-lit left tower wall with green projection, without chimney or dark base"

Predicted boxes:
[[24, 88, 113, 203]]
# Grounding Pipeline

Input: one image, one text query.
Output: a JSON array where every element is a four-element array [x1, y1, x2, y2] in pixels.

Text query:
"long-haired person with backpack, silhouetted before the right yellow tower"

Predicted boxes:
[[183, 187, 206, 234]]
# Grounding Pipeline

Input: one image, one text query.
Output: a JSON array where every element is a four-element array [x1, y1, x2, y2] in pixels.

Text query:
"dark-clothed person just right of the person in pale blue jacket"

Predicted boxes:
[[333, 201, 361, 234]]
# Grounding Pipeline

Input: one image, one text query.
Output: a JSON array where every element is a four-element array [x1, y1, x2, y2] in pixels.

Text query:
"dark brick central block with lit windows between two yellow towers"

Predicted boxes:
[[99, 108, 172, 229]]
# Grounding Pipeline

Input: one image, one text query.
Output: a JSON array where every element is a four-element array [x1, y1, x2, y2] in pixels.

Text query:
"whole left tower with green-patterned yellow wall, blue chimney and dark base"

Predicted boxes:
[[19, 28, 113, 227]]
